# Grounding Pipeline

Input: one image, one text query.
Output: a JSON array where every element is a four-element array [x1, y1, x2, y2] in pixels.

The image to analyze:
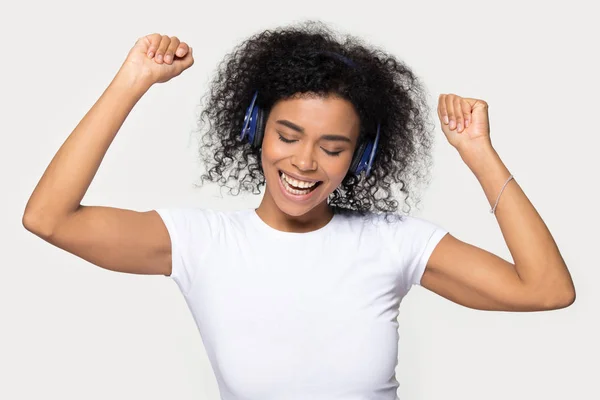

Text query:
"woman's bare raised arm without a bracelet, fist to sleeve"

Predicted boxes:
[[23, 34, 193, 275]]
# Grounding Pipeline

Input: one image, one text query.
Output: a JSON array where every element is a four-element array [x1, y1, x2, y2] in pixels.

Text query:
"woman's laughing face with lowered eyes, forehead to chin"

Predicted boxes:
[[262, 96, 360, 216]]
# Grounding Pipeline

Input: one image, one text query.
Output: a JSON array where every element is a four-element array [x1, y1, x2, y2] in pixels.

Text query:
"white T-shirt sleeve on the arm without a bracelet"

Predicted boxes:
[[155, 208, 221, 294]]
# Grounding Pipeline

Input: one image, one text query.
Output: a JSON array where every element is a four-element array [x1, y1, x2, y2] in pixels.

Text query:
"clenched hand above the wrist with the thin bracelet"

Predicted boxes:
[[437, 94, 492, 156]]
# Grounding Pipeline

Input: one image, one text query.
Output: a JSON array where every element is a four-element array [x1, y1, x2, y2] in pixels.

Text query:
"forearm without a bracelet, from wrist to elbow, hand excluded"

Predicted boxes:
[[23, 71, 149, 230]]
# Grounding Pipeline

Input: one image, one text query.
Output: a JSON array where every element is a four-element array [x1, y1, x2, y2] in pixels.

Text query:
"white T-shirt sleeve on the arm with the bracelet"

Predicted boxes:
[[396, 216, 448, 292]]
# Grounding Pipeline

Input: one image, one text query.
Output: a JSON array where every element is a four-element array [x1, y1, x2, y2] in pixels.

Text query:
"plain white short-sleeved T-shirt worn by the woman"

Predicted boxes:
[[156, 208, 447, 400]]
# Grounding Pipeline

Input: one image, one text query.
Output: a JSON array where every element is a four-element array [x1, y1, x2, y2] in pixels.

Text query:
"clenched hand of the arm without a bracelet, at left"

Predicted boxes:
[[119, 33, 194, 86]]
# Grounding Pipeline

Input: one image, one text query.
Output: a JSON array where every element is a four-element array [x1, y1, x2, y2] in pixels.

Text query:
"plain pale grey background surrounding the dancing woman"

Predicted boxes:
[[0, 0, 600, 400]]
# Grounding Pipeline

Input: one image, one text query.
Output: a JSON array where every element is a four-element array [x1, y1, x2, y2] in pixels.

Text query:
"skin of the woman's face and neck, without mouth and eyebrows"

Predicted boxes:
[[256, 96, 360, 232]]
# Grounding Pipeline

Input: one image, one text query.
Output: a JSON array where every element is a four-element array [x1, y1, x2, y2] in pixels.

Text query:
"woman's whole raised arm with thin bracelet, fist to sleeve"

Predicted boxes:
[[421, 94, 575, 311]]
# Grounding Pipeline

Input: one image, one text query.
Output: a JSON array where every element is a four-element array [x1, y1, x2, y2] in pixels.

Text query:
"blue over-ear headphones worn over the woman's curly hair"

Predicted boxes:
[[240, 52, 381, 176]]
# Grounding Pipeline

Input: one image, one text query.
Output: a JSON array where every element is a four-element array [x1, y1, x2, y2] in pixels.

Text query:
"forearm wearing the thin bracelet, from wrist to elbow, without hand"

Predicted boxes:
[[461, 146, 575, 302]]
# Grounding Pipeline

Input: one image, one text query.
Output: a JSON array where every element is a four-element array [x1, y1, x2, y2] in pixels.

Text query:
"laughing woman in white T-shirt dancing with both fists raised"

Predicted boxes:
[[23, 24, 575, 399]]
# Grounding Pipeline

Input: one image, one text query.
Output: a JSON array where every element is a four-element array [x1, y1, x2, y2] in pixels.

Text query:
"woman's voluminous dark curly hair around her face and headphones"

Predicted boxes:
[[198, 21, 433, 214]]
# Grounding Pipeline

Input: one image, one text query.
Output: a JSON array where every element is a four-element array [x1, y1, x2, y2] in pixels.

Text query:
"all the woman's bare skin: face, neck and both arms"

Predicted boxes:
[[23, 29, 575, 311]]
